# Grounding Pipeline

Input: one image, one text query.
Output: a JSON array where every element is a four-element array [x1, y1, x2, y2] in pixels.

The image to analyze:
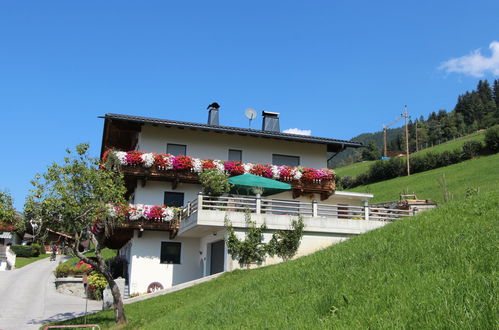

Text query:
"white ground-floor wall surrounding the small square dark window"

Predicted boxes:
[[129, 230, 204, 294]]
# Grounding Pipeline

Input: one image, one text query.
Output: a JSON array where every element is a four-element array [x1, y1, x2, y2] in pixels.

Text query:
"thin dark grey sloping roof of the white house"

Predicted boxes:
[[100, 113, 362, 151]]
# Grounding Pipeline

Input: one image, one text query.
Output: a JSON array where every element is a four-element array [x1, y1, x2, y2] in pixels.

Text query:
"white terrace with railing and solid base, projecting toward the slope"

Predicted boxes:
[[178, 194, 413, 237]]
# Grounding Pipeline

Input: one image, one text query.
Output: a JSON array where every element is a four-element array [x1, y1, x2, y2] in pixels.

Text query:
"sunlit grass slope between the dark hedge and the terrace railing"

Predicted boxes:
[[350, 154, 499, 203]]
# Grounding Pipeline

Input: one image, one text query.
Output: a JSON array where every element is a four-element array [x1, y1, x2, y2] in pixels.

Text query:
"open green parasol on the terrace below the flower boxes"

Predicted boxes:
[[229, 173, 291, 196]]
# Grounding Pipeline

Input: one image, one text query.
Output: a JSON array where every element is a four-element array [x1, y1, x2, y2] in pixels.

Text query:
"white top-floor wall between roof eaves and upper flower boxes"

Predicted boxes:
[[138, 125, 327, 168]]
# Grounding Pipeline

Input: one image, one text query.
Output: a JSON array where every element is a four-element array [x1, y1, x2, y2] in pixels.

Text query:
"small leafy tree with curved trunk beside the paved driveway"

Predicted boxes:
[[25, 144, 126, 323]]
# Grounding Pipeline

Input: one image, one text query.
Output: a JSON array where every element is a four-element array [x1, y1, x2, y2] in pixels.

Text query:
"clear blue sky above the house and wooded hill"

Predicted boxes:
[[0, 0, 499, 209]]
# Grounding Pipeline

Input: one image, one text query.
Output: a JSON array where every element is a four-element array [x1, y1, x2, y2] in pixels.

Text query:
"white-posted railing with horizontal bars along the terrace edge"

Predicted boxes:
[[181, 194, 414, 221]]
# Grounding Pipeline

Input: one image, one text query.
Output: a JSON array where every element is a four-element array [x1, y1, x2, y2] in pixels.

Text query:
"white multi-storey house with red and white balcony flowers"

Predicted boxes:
[[101, 107, 407, 293]]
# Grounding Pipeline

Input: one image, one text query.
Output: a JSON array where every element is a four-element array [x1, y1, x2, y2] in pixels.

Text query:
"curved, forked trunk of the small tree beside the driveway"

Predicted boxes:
[[74, 233, 127, 324]]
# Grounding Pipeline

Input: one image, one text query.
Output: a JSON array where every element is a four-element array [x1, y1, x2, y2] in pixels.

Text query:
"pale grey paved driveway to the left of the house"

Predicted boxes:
[[0, 256, 102, 330]]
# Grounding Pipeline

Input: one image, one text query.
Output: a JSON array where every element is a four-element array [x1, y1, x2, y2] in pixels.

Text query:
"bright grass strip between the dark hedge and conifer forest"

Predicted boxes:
[[334, 130, 485, 177]]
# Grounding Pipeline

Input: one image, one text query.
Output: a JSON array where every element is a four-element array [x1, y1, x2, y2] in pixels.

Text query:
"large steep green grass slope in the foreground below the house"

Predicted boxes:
[[52, 192, 499, 329]]
